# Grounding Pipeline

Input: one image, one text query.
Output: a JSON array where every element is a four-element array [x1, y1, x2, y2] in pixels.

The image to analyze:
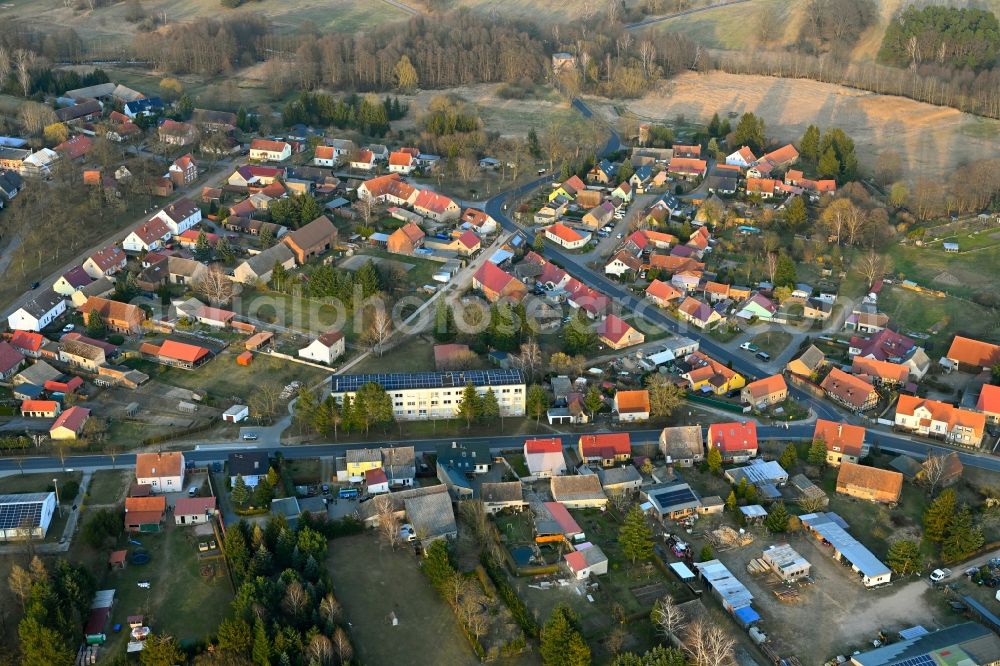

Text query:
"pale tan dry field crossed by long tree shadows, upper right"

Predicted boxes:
[[588, 72, 1000, 179]]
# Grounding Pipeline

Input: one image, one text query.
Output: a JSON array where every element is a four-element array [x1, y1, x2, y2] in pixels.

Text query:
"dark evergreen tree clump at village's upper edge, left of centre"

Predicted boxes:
[[281, 92, 410, 136]]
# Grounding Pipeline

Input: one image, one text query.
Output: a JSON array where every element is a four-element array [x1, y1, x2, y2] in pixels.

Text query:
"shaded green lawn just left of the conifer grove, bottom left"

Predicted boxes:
[[103, 519, 233, 654]]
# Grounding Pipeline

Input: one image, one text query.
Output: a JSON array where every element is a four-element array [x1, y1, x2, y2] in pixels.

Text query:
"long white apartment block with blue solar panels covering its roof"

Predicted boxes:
[[330, 369, 525, 421]]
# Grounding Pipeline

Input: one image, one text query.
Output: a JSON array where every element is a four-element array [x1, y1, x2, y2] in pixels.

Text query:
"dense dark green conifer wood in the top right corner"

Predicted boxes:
[[878, 5, 1000, 70]]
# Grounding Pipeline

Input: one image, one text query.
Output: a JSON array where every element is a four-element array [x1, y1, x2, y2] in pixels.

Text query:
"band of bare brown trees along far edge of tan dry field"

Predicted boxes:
[[711, 51, 1000, 118]]
